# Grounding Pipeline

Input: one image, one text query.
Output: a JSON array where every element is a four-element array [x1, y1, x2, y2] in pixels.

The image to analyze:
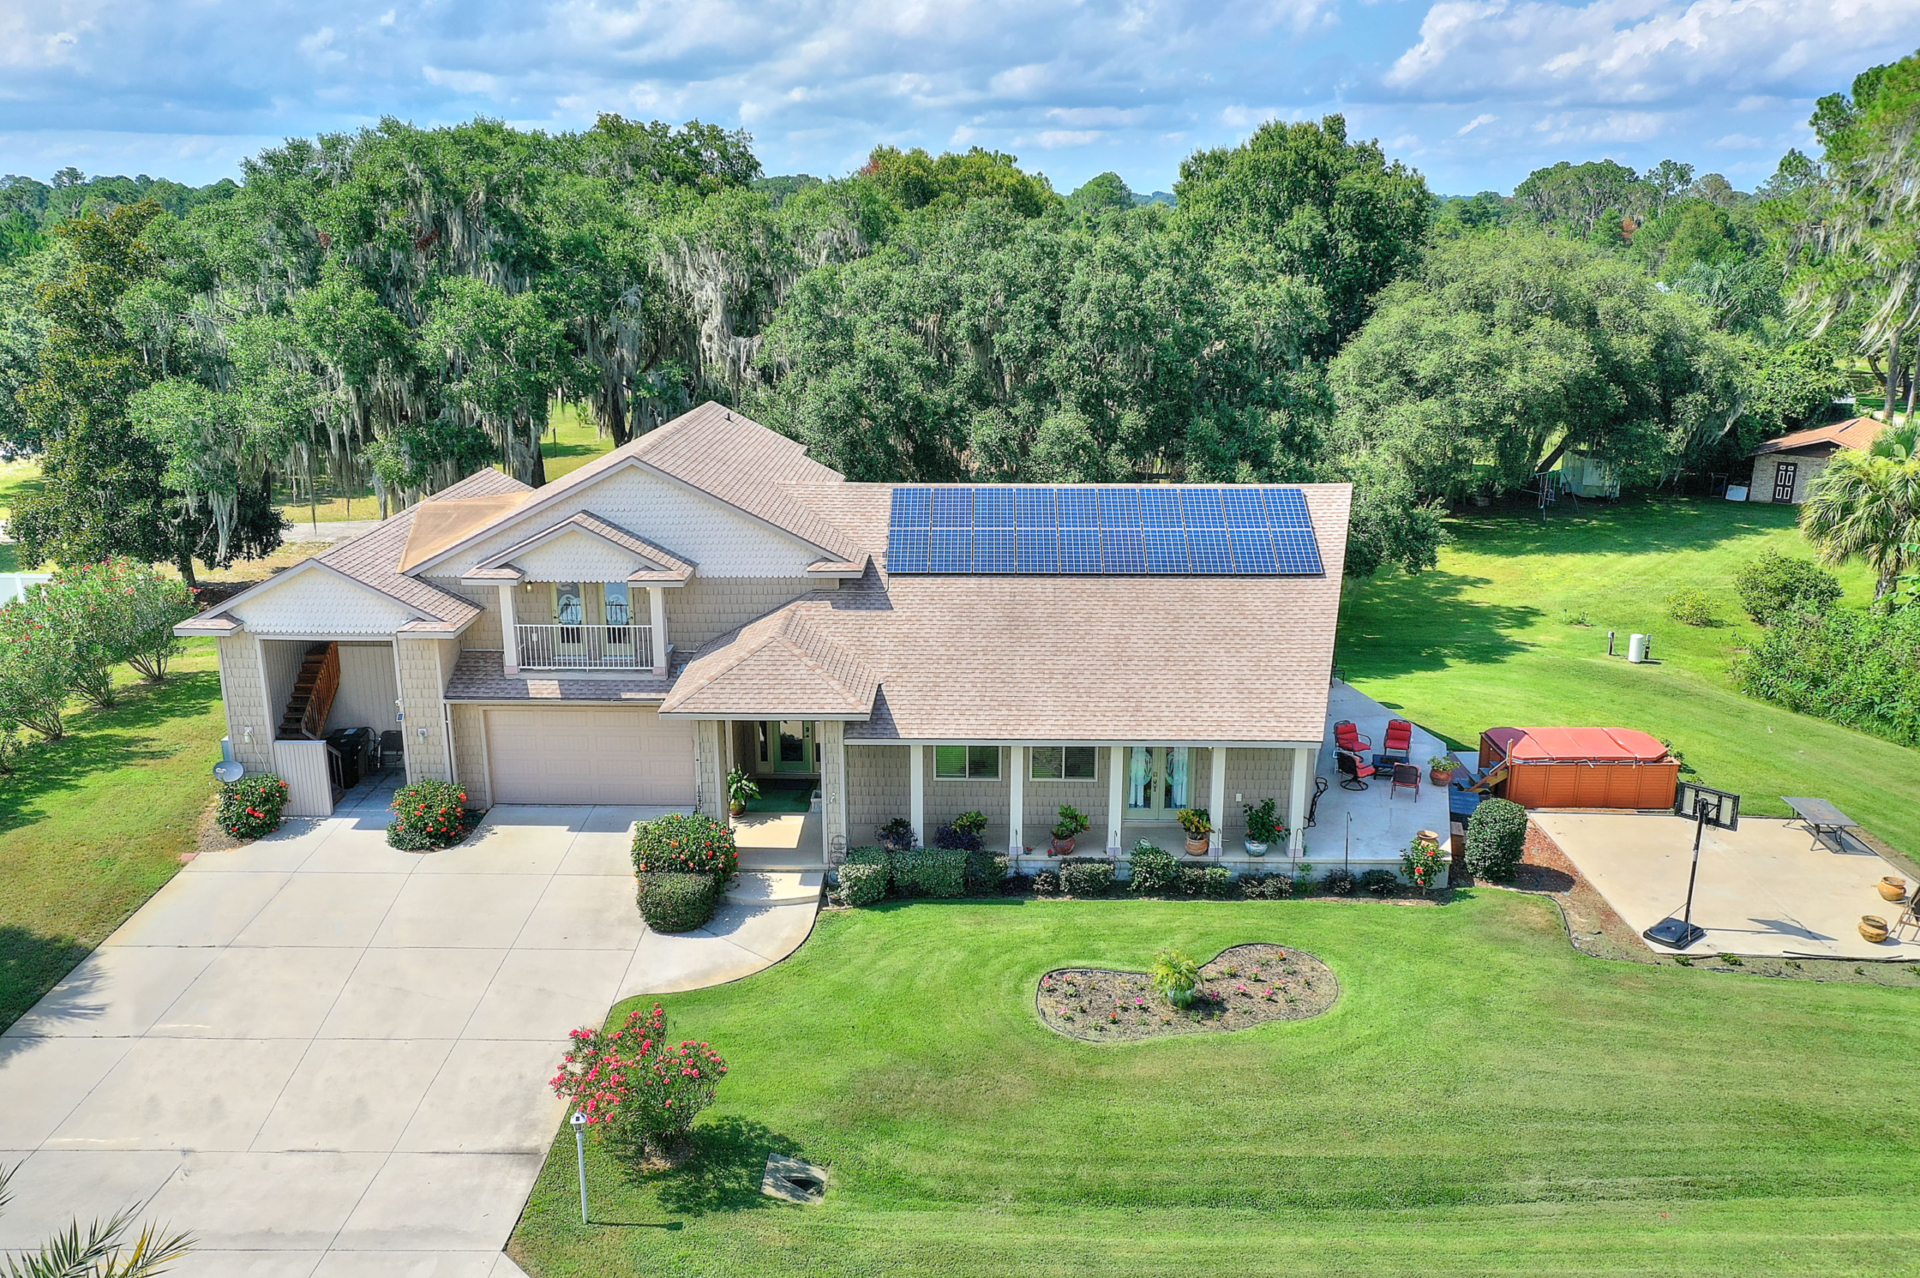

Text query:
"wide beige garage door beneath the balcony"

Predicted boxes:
[[486, 708, 693, 808]]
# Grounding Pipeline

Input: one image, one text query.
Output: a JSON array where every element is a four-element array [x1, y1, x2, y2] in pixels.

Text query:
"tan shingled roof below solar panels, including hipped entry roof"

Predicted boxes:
[[668, 484, 1352, 743]]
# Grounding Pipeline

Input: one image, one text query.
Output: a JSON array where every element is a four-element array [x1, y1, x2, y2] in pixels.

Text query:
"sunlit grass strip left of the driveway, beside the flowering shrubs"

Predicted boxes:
[[0, 639, 227, 1029]]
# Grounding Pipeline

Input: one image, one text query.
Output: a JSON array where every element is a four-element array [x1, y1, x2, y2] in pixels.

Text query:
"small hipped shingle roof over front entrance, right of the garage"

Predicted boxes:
[[660, 606, 879, 720]]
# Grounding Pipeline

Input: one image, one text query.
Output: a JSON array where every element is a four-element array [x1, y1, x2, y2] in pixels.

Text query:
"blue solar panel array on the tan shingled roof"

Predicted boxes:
[[887, 484, 1323, 576]]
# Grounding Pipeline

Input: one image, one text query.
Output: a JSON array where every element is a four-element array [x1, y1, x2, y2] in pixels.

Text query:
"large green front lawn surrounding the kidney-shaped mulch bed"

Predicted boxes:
[[509, 890, 1920, 1278]]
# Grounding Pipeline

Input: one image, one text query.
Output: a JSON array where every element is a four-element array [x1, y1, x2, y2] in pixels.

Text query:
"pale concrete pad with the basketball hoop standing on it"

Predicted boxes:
[[1532, 812, 1920, 961]]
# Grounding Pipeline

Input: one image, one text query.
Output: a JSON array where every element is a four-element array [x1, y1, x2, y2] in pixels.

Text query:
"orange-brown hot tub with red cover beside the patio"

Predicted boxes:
[[1480, 727, 1680, 810]]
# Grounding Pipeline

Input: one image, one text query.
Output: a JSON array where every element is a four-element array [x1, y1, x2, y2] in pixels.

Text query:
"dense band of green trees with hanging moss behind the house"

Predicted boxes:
[[0, 59, 1920, 576]]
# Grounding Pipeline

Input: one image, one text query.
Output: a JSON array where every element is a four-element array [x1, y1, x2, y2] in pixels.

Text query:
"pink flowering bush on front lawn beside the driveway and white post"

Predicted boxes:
[[553, 1004, 726, 1151]]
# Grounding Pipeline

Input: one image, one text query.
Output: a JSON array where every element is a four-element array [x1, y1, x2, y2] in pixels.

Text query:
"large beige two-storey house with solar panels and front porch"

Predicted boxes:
[[179, 403, 1352, 852]]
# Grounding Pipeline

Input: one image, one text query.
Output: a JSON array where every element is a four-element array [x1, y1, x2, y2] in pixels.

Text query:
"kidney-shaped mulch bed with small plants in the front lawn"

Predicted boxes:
[[1035, 942, 1340, 1042]]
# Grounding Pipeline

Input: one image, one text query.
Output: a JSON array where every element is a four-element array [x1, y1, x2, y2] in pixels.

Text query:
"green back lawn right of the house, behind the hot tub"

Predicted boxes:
[[1336, 499, 1920, 854]]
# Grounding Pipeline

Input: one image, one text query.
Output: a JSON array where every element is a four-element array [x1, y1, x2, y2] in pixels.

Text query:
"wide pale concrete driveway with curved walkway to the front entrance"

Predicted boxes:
[[0, 789, 818, 1278]]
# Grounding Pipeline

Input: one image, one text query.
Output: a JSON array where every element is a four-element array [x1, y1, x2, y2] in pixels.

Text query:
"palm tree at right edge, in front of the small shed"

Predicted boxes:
[[1801, 449, 1920, 603]]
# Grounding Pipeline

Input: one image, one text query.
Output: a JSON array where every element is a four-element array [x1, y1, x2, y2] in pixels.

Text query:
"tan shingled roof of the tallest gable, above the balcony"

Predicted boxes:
[[409, 401, 862, 572]]
